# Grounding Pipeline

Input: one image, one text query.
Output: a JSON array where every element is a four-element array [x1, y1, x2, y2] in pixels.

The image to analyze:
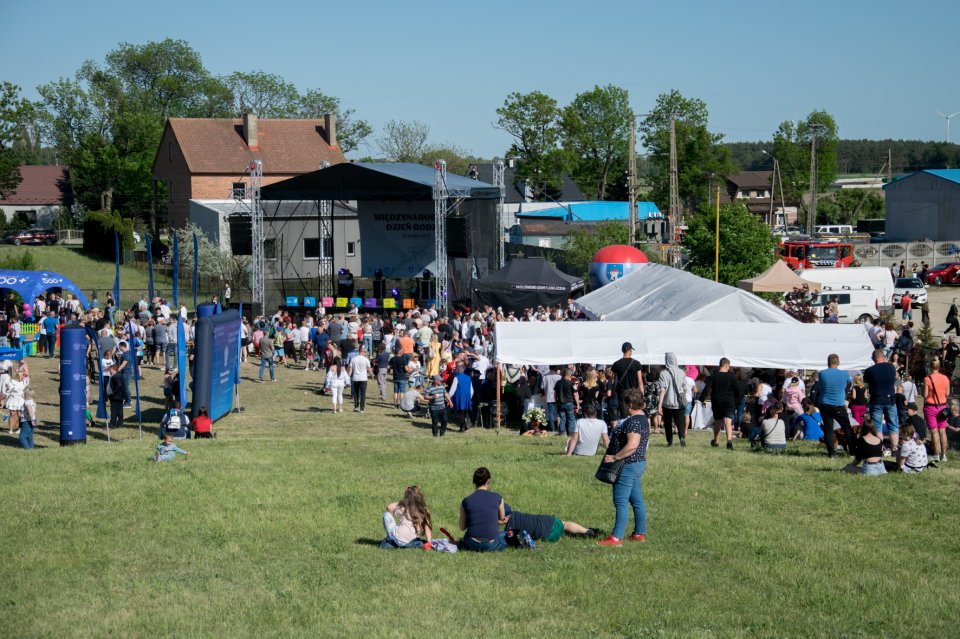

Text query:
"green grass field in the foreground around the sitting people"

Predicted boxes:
[[0, 359, 960, 637]]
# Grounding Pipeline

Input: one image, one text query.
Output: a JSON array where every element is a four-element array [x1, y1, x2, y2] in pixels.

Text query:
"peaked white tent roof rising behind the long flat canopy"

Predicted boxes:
[[576, 264, 800, 324]]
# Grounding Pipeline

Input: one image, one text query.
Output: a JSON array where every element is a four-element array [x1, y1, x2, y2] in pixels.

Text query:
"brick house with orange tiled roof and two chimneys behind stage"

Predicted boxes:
[[153, 114, 345, 228]]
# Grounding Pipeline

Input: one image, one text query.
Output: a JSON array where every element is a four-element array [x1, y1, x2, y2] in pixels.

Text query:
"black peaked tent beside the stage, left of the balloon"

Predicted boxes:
[[472, 258, 583, 313]]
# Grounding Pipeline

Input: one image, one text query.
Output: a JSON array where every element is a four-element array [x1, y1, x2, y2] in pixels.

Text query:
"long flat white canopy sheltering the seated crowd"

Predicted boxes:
[[494, 321, 873, 370]]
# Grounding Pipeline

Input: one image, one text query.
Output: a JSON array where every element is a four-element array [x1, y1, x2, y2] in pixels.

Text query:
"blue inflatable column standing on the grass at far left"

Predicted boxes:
[[60, 326, 87, 446]]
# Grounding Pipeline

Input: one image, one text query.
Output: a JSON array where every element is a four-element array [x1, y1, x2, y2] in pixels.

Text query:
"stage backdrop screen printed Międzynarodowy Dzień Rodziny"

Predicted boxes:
[[357, 202, 437, 278]]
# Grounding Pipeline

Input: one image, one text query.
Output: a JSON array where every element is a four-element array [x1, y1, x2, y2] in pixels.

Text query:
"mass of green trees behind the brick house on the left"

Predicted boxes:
[[0, 39, 372, 230]]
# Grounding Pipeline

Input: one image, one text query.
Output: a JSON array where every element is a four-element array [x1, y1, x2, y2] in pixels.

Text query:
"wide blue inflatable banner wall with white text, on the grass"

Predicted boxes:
[[190, 310, 240, 421]]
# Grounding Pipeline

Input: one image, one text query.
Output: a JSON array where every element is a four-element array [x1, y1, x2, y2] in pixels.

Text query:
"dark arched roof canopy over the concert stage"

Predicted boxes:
[[260, 162, 500, 201]]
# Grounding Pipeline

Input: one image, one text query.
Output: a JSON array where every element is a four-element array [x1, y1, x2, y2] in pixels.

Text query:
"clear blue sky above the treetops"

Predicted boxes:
[[0, 0, 960, 157]]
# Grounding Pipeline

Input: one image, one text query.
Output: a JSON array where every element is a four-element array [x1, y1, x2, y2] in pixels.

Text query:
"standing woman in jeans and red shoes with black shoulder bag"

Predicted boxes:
[[597, 389, 650, 546]]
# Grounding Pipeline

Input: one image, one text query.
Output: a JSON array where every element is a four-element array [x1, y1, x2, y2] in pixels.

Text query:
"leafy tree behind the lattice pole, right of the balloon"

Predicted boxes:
[[639, 89, 734, 211]]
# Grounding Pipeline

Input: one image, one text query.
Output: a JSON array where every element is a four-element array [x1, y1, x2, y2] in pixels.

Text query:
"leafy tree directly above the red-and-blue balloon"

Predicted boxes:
[[560, 85, 633, 200]]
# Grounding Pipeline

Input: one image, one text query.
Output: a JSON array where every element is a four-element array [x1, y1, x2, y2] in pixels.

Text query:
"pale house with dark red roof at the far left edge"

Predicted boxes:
[[0, 166, 73, 229]]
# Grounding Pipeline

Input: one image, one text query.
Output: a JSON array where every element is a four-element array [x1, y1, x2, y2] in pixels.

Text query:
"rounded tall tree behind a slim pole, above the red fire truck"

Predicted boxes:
[[773, 111, 837, 221]]
